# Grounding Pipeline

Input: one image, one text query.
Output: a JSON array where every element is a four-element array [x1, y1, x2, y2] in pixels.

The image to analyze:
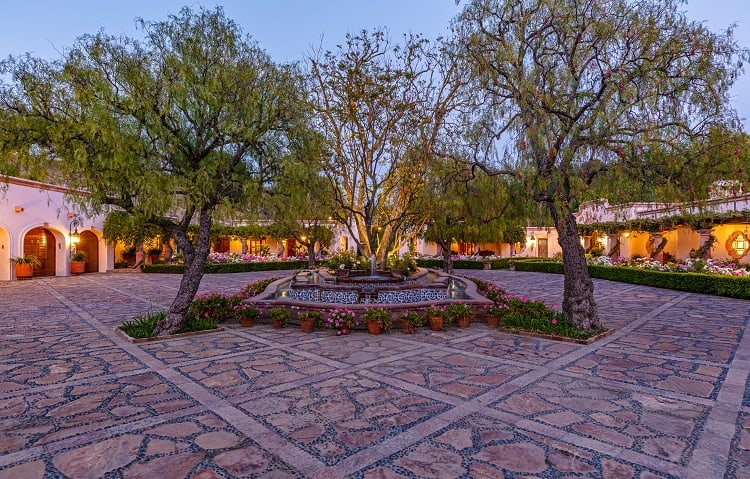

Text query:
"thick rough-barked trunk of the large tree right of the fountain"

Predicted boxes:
[[550, 204, 601, 331]]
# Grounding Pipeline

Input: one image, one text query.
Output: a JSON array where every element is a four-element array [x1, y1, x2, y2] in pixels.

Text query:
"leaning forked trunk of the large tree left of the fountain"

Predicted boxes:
[[154, 208, 213, 336]]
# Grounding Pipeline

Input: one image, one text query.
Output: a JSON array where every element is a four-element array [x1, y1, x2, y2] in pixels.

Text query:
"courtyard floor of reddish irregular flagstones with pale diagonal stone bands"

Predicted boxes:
[[0, 271, 750, 479]]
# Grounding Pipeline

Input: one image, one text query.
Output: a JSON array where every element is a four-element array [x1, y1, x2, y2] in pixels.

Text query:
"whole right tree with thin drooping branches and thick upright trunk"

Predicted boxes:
[[455, 0, 747, 329]]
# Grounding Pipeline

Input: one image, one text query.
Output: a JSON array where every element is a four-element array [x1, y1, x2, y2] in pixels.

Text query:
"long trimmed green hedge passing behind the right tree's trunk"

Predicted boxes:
[[508, 261, 750, 299]]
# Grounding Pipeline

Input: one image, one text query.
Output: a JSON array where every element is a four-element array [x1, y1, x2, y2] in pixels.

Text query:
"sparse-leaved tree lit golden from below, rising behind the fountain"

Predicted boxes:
[[309, 30, 476, 264]]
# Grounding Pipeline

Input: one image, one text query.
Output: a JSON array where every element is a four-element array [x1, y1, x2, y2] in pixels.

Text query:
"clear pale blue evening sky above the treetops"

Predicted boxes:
[[0, 0, 750, 131]]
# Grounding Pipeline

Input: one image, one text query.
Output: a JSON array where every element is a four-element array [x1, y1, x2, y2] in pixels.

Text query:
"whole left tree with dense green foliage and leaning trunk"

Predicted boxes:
[[0, 8, 305, 334]]
